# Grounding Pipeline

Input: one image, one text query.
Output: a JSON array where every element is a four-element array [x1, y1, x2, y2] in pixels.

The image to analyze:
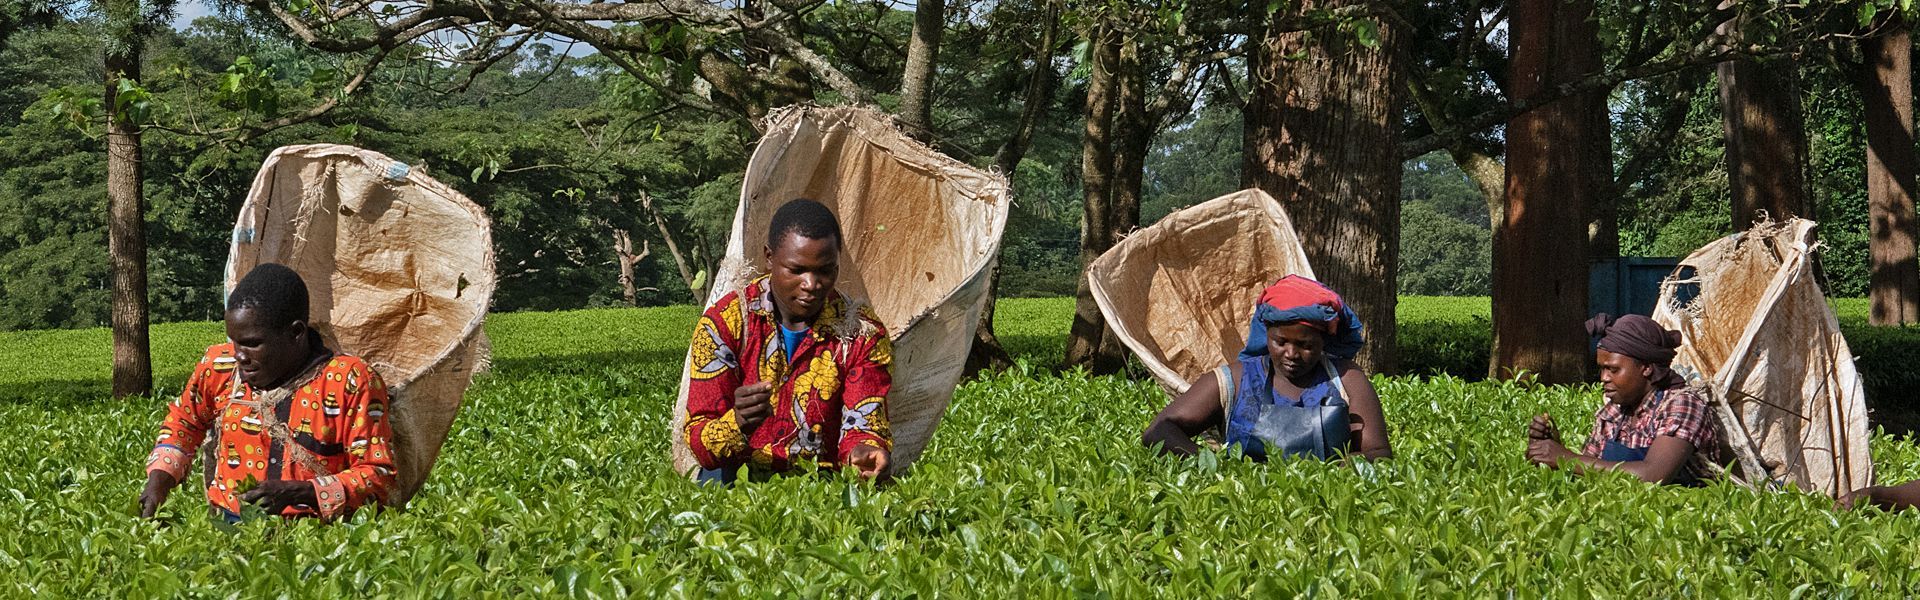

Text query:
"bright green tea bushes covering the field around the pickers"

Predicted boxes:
[[0, 300, 1920, 598]]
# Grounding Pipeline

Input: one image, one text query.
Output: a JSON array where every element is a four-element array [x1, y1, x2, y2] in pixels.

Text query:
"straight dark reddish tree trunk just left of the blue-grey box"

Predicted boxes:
[[1490, 0, 1605, 383]]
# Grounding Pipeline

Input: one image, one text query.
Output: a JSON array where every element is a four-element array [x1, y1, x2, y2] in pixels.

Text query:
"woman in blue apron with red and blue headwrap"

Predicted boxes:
[[1140, 275, 1394, 460]]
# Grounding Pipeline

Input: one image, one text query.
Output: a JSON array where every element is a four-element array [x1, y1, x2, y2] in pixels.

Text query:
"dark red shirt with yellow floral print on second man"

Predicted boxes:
[[684, 277, 893, 471]]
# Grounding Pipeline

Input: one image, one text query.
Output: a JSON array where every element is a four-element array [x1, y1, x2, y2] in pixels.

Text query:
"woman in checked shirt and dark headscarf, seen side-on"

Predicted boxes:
[[1526, 313, 1720, 485]]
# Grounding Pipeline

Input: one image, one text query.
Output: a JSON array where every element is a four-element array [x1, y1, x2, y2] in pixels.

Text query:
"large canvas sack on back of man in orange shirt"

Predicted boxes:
[[227, 144, 495, 506]]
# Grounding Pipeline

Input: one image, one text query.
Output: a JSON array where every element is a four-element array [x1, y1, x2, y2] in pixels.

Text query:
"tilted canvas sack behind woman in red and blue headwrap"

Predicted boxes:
[[1087, 188, 1313, 394]]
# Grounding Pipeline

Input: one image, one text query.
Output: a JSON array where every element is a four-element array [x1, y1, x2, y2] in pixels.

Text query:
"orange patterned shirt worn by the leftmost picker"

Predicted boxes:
[[146, 342, 394, 519]]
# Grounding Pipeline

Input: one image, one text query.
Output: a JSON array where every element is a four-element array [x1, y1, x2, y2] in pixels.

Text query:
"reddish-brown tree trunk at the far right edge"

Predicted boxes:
[[1857, 23, 1920, 325]]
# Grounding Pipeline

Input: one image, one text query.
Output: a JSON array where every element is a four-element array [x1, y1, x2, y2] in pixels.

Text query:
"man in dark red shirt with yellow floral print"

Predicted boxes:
[[682, 200, 893, 481]]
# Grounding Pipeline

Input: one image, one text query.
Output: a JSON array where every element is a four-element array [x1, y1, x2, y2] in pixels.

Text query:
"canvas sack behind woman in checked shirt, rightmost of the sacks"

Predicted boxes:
[[1653, 219, 1874, 496]]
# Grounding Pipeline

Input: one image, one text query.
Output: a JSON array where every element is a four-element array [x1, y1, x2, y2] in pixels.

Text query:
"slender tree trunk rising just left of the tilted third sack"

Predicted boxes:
[[1066, 23, 1121, 373]]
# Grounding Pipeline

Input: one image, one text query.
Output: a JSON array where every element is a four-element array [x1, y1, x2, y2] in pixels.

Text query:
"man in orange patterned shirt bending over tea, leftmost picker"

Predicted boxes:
[[140, 263, 394, 519]]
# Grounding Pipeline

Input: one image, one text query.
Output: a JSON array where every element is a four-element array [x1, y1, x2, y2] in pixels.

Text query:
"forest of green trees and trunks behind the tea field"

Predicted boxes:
[[0, 0, 1920, 394]]
